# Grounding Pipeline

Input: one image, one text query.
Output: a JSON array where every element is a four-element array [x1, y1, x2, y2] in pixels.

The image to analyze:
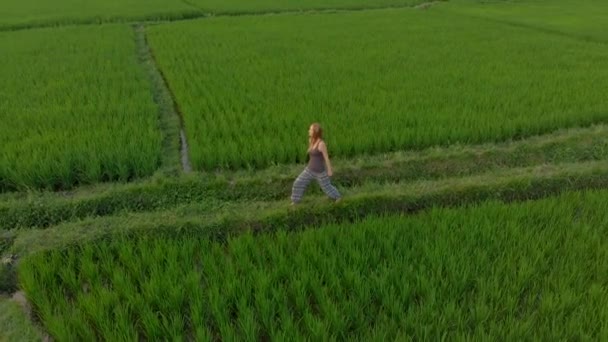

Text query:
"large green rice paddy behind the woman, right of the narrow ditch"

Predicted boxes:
[[149, 6, 608, 170]]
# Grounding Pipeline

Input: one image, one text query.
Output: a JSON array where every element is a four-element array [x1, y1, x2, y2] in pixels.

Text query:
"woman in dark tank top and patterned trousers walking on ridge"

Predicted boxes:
[[291, 123, 341, 205]]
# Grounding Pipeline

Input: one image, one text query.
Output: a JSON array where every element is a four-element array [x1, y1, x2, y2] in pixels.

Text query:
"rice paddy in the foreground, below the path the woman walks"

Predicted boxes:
[[19, 190, 608, 340]]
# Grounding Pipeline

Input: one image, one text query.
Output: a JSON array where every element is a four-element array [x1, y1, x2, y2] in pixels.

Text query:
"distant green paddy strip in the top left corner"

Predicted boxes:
[[0, 0, 202, 29]]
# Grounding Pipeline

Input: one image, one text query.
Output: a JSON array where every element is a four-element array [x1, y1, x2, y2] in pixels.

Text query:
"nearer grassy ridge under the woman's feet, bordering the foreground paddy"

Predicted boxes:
[[9, 161, 608, 258]]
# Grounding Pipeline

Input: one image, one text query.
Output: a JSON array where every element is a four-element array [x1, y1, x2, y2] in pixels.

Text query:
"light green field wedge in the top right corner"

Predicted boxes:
[[441, 0, 608, 42]]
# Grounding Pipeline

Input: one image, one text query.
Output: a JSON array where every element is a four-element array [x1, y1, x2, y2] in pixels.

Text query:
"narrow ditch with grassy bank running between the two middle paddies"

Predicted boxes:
[[133, 24, 192, 175]]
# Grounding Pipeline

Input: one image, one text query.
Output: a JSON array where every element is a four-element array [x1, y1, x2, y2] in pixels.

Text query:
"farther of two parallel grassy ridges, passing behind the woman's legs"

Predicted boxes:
[[0, 125, 608, 230]]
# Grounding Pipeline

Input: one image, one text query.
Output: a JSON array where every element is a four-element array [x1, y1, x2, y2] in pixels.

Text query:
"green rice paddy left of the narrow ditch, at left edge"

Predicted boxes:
[[0, 26, 162, 191]]
